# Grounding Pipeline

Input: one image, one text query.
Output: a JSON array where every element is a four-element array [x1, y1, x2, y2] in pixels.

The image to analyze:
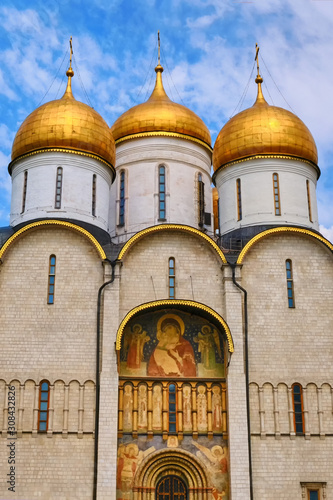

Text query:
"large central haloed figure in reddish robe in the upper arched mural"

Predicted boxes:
[[147, 314, 196, 377]]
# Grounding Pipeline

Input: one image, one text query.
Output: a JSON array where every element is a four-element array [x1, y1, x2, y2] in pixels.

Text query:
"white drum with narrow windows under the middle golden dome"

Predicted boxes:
[[110, 137, 213, 241]]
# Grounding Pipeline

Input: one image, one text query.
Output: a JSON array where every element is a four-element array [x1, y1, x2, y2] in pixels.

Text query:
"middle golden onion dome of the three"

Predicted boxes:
[[111, 64, 211, 150]]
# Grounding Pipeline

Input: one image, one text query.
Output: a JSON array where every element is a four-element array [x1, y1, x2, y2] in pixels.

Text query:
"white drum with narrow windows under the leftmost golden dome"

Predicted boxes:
[[10, 152, 113, 231]]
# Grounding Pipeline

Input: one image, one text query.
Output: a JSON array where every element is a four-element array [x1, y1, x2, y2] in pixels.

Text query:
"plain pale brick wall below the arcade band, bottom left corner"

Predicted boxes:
[[0, 434, 94, 500]]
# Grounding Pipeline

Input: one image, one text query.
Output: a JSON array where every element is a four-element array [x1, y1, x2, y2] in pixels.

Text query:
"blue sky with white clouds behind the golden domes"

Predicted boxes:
[[0, 0, 333, 240]]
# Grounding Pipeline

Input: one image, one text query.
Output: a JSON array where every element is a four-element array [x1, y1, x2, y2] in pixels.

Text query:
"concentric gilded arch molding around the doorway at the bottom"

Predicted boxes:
[[133, 448, 212, 500]]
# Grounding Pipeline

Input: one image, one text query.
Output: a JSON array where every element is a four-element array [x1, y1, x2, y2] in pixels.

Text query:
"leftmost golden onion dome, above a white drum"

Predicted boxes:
[[12, 67, 116, 167]]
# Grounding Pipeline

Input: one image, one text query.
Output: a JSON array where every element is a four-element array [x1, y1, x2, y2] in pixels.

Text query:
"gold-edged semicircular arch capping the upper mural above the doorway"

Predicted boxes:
[[116, 299, 234, 353]]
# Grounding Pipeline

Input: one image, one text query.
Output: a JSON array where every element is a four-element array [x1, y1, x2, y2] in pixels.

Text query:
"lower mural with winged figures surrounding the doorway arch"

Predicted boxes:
[[117, 435, 229, 500]]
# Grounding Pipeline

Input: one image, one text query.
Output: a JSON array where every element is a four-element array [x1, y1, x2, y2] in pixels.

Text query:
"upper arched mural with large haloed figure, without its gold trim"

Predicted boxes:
[[120, 310, 224, 378]]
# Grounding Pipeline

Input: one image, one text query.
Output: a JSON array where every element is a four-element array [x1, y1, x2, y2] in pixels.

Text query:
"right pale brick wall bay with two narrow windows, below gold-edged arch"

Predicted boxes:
[[241, 234, 333, 500]]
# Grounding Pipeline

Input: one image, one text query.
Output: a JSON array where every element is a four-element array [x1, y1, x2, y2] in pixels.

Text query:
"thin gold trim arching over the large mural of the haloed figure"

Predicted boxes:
[[116, 299, 234, 353]]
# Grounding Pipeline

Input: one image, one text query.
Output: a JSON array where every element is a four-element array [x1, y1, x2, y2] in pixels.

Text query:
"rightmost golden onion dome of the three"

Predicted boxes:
[[213, 74, 318, 172]]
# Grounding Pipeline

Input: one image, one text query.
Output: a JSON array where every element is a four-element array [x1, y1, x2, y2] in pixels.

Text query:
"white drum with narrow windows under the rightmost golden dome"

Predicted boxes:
[[216, 159, 319, 234]]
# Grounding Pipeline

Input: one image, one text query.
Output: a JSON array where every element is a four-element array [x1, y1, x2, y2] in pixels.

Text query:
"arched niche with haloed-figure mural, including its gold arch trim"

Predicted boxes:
[[116, 300, 233, 379]]
